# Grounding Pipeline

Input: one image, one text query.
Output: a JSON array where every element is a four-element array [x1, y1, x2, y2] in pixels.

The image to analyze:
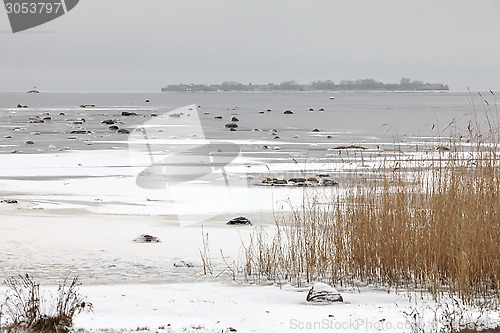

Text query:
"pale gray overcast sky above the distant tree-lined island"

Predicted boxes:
[[0, 0, 500, 91]]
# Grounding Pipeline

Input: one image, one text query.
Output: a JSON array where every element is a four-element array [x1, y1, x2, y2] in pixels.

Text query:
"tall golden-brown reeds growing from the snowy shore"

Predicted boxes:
[[245, 104, 500, 304]]
